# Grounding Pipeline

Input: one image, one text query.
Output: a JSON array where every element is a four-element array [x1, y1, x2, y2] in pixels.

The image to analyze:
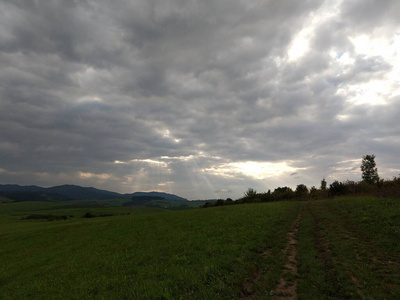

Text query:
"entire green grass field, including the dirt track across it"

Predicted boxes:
[[0, 198, 400, 299]]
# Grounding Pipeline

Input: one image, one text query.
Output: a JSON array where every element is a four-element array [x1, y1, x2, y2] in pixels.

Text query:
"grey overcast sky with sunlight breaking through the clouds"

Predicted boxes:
[[0, 0, 400, 199]]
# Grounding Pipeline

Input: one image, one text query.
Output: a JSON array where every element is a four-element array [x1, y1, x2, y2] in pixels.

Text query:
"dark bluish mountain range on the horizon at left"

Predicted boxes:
[[0, 184, 188, 201]]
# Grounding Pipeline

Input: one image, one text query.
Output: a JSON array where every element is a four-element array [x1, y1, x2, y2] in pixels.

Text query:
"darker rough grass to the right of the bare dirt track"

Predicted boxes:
[[298, 198, 400, 299]]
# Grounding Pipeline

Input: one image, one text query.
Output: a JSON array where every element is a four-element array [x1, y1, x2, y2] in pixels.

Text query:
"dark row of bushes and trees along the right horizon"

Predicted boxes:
[[202, 154, 400, 208]]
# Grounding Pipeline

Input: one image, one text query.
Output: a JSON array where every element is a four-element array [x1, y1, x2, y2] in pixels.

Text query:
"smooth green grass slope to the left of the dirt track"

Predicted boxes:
[[0, 203, 297, 299]]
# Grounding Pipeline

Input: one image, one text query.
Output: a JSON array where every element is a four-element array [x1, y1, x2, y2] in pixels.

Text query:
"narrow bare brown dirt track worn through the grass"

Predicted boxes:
[[273, 215, 301, 299]]
